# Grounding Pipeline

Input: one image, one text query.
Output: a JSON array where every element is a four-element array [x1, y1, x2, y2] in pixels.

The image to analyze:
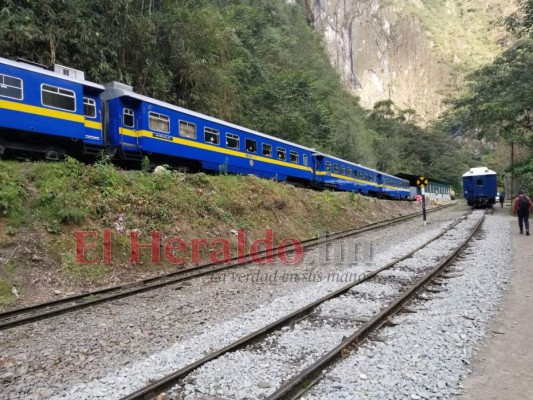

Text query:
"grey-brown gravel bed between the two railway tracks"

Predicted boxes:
[[0, 206, 468, 400]]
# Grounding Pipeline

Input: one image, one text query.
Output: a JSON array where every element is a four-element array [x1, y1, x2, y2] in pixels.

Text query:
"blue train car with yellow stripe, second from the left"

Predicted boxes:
[[102, 83, 314, 183]]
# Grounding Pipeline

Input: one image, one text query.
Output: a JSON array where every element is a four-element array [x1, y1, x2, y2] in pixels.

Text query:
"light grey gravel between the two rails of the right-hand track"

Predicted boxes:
[[170, 212, 482, 400]]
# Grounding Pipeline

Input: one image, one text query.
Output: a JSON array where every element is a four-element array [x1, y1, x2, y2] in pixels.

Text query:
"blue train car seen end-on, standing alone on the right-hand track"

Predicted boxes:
[[463, 167, 497, 207]]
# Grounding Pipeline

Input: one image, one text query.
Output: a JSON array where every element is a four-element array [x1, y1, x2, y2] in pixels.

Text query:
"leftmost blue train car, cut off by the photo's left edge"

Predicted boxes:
[[0, 58, 105, 159]]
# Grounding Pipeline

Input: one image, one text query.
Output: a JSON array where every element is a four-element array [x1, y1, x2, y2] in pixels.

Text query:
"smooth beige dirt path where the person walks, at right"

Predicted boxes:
[[459, 207, 533, 400]]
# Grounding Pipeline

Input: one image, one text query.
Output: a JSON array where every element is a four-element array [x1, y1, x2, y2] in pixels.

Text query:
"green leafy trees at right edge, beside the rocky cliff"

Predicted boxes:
[[442, 0, 533, 191]]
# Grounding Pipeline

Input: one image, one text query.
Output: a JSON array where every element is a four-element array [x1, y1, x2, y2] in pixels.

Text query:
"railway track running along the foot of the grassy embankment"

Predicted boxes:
[[0, 203, 454, 331]]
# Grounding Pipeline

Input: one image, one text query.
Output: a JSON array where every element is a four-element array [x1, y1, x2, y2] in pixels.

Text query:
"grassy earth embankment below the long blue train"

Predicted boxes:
[[0, 159, 416, 307]]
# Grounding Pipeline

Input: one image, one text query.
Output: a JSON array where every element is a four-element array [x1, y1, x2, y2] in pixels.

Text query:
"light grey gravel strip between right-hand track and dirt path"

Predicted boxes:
[[304, 211, 511, 400]]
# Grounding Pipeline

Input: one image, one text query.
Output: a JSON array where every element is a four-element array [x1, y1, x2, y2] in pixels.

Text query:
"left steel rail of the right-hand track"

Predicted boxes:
[[120, 206, 472, 400]]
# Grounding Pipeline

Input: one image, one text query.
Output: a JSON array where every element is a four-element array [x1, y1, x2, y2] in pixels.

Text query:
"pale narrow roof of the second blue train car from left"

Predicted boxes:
[[102, 82, 316, 153]]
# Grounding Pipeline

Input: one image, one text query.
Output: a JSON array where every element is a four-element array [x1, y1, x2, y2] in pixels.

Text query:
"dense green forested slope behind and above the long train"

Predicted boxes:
[[0, 0, 464, 182]]
